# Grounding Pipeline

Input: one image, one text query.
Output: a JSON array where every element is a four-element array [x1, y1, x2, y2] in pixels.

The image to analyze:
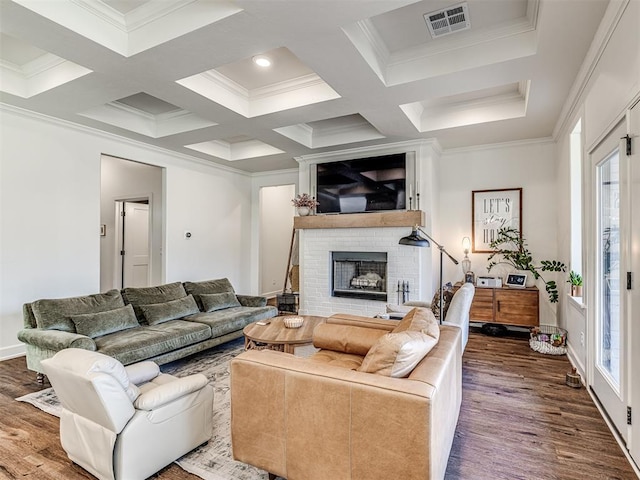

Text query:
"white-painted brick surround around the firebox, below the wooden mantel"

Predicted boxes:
[[300, 221, 432, 316]]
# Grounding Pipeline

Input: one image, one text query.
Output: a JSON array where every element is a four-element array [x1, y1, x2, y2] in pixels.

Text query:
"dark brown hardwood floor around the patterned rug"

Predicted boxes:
[[0, 332, 637, 480]]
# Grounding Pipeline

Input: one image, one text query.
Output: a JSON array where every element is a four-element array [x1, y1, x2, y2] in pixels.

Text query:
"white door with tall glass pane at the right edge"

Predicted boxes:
[[590, 122, 629, 442]]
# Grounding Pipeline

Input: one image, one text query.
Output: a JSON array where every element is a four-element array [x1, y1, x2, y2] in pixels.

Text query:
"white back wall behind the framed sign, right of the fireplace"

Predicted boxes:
[[436, 140, 564, 325]]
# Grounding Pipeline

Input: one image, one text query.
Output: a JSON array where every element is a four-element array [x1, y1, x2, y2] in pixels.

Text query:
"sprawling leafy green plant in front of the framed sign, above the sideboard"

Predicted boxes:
[[487, 227, 567, 303]]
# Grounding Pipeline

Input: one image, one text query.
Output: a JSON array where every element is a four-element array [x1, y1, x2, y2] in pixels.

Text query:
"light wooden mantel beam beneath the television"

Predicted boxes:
[[293, 210, 425, 229]]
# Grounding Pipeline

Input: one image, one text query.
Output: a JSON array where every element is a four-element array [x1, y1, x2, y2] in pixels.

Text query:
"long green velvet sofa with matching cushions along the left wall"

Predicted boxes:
[[18, 278, 278, 381]]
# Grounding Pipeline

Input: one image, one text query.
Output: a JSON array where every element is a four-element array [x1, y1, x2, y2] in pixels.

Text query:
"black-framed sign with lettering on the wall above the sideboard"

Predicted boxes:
[[471, 188, 522, 253]]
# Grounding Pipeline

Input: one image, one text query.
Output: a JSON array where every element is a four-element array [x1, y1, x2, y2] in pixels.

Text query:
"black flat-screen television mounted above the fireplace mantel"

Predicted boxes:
[[316, 153, 407, 213]]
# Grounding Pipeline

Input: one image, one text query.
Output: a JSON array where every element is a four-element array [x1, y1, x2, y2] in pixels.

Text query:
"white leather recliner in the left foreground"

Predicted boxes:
[[42, 348, 213, 480]]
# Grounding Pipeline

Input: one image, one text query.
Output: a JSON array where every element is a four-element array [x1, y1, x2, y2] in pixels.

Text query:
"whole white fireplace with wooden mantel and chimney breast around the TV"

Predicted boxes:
[[294, 140, 441, 316]]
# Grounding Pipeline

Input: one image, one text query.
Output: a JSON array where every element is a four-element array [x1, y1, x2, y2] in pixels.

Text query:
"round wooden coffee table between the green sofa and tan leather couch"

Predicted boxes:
[[242, 315, 326, 353]]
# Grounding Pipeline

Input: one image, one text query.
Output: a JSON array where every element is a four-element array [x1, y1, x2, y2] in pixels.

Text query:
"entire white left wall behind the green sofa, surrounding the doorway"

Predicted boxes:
[[0, 106, 257, 358]]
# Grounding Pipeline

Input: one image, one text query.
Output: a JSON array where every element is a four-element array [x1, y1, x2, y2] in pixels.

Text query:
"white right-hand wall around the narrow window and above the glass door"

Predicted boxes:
[[556, 0, 640, 377]]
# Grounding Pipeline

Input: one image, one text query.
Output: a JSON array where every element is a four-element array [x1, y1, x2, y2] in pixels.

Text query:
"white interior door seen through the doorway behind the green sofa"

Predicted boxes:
[[122, 202, 149, 288]]
